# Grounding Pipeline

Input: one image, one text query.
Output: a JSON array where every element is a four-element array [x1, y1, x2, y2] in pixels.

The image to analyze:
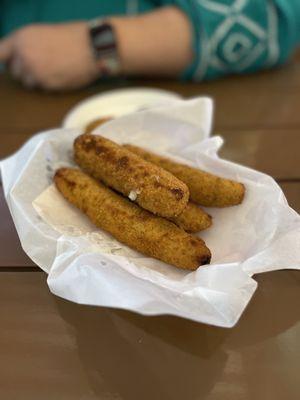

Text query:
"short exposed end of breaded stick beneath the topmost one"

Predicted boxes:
[[169, 202, 212, 233]]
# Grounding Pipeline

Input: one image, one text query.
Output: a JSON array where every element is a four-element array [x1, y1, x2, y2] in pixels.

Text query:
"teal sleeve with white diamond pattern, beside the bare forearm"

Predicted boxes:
[[166, 0, 300, 81]]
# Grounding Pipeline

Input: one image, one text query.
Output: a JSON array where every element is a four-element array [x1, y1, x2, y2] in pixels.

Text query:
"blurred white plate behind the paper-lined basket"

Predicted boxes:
[[63, 88, 180, 128]]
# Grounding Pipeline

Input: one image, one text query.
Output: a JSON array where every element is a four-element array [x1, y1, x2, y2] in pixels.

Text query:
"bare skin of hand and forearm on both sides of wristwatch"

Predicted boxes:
[[0, 7, 192, 89]]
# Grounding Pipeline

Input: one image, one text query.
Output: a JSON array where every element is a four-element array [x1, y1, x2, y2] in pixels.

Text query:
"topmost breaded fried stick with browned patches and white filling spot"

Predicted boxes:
[[74, 135, 189, 218]]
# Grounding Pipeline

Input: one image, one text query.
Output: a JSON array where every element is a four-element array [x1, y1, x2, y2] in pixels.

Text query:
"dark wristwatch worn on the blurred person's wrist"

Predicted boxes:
[[88, 18, 121, 76]]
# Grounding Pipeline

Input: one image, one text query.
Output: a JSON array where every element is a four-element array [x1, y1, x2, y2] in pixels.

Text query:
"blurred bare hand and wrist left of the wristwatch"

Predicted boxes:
[[0, 22, 98, 90]]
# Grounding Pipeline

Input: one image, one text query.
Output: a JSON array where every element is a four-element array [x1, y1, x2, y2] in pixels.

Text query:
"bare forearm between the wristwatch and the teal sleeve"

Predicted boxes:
[[111, 7, 193, 77]]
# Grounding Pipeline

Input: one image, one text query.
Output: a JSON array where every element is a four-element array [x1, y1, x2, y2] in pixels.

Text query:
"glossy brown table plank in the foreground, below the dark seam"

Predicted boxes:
[[0, 271, 300, 400]]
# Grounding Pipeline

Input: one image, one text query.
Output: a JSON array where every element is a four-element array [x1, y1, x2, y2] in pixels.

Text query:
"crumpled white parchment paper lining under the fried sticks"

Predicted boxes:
[[1, 98, 300, 327]]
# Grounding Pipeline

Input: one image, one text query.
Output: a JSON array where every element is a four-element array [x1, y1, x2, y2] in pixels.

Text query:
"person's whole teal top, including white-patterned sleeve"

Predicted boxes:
[[0, 0, 300, 81]]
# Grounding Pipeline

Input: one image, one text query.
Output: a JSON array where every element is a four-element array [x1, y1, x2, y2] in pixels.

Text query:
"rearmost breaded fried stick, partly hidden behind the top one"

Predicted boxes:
[[124, 144, 245, 207]]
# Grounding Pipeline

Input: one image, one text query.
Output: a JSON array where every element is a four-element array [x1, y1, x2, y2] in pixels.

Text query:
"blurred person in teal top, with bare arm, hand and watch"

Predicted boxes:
[[0, 0, 300, 90]]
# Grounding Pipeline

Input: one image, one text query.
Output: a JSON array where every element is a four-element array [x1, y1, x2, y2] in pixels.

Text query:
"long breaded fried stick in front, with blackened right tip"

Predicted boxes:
[[54, 168, 211, 270]]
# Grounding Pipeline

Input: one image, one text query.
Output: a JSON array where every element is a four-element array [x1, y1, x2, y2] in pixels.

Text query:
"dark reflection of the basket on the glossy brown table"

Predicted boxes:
[[56, 299, 229, 400]]
